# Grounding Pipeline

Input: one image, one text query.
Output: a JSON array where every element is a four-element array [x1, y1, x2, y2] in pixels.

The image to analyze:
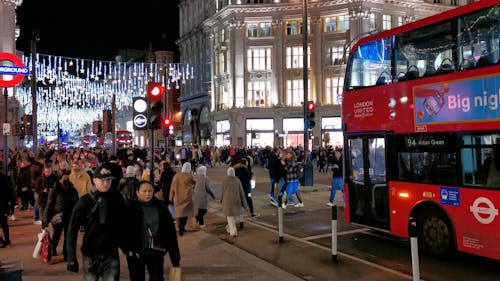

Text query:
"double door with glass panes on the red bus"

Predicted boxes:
[[345, 133, 389, 230]]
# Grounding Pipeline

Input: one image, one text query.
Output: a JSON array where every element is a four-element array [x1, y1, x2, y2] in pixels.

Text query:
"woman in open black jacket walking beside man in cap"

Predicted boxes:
[[122, 181, 181, 281]]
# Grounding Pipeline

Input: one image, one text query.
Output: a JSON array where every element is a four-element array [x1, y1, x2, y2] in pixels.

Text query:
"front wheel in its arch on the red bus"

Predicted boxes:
[[408, 202, 457, 258]]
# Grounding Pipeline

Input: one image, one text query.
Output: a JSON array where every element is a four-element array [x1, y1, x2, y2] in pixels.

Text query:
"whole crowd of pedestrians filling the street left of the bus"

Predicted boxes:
[[0, 142, 343, 280]]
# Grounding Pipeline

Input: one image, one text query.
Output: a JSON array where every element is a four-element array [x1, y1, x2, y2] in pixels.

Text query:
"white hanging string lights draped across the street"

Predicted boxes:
[[16, 54, 193, 136]]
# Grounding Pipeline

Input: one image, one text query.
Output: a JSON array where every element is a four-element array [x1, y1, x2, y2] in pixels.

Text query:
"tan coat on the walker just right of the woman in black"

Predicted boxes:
[[169, 173, 196, 218]]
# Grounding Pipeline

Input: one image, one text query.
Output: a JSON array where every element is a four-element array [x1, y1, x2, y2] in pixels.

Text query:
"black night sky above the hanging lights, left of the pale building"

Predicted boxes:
[[16, 0, 179, 60]]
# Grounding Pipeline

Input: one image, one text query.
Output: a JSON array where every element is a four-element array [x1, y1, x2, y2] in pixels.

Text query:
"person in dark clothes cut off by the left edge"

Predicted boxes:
[[0, 172, 15, 248]]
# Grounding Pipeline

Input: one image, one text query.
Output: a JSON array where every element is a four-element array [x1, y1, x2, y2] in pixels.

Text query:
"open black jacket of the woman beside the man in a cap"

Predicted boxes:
[[122, 197, 180, 266]]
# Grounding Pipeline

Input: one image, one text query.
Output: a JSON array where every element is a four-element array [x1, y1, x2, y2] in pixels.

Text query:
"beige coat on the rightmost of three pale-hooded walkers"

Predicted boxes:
[[220, 176, 248, 216]]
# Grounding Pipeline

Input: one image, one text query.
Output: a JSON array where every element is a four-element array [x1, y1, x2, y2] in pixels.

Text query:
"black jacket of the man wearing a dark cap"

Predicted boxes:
[[66, 190, 125, 261]]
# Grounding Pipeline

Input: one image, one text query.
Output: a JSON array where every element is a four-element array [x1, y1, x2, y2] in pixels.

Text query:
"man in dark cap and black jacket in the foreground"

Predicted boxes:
[[66, 166, 125, 280]]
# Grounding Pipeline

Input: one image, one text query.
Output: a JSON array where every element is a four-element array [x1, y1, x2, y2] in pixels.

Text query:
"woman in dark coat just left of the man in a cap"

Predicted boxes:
[[42, 172, 78, 260]]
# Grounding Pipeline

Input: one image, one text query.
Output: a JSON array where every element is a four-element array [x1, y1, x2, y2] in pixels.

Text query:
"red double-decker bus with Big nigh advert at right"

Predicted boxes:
[[342, 1, 500, 260]]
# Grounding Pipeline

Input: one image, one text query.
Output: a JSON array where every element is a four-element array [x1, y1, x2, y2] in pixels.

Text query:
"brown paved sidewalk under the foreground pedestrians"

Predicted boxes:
[[0, 206, 302, 281]]
